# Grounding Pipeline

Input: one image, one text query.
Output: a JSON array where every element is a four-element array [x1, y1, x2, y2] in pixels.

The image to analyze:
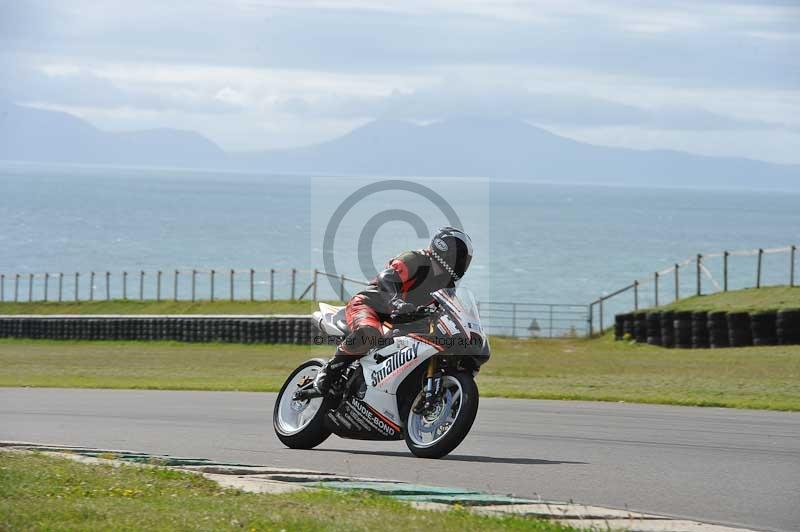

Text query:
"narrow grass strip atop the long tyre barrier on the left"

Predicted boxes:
[[0, 299, 336, 315]]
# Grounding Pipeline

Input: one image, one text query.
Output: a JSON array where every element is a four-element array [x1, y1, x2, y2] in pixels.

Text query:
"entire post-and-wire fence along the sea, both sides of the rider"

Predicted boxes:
[[10, 245, 797, 338]]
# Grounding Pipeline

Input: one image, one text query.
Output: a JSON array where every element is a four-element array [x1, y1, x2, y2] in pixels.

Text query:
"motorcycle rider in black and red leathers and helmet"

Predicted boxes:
[[314, 227, 472, 395]]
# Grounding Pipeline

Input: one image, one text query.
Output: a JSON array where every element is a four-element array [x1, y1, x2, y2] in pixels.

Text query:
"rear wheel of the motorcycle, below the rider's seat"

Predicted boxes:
[[272, 359, 331, 449]]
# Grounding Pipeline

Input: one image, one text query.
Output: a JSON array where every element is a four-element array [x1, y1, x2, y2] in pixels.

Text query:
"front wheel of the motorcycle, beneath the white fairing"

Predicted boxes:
[[405, 372, 479, 458]]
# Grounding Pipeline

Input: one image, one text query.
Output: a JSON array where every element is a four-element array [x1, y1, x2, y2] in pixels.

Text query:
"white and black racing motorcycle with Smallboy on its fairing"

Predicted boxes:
[[272, 288, 490, 458]]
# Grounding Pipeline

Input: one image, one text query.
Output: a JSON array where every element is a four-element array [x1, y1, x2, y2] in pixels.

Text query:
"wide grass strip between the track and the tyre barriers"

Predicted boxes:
[[0, 336, 800, 410]]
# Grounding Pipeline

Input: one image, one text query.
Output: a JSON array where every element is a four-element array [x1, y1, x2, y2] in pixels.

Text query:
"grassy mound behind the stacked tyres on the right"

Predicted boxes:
[[658, 286, 800, 312]]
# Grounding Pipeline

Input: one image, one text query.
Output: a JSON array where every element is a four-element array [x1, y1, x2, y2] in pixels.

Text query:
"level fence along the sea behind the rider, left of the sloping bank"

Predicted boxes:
[[0, 268, 589, 338]]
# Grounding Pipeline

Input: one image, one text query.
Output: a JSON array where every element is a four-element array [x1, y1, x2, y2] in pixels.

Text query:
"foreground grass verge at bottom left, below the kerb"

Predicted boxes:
[[0, 452, 567, 532]]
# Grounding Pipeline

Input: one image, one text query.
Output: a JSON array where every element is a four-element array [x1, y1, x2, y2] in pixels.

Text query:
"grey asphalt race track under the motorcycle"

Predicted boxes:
[[0, 388, 800, 531]]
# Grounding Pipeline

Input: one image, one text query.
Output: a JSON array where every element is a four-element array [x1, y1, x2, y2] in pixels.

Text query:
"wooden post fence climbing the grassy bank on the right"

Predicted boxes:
[[588, 245, 797, 336]]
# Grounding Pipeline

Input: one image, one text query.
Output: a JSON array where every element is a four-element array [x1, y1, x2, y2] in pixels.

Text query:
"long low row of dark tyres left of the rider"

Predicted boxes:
[[0, 316, 328, 345]]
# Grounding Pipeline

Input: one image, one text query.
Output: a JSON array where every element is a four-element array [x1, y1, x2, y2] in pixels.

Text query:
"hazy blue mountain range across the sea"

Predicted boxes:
[[0, 103, 800, 189]]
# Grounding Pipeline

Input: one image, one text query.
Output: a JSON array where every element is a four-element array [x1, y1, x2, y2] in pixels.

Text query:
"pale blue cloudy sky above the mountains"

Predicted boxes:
[[0, 0, 800, 163]]
